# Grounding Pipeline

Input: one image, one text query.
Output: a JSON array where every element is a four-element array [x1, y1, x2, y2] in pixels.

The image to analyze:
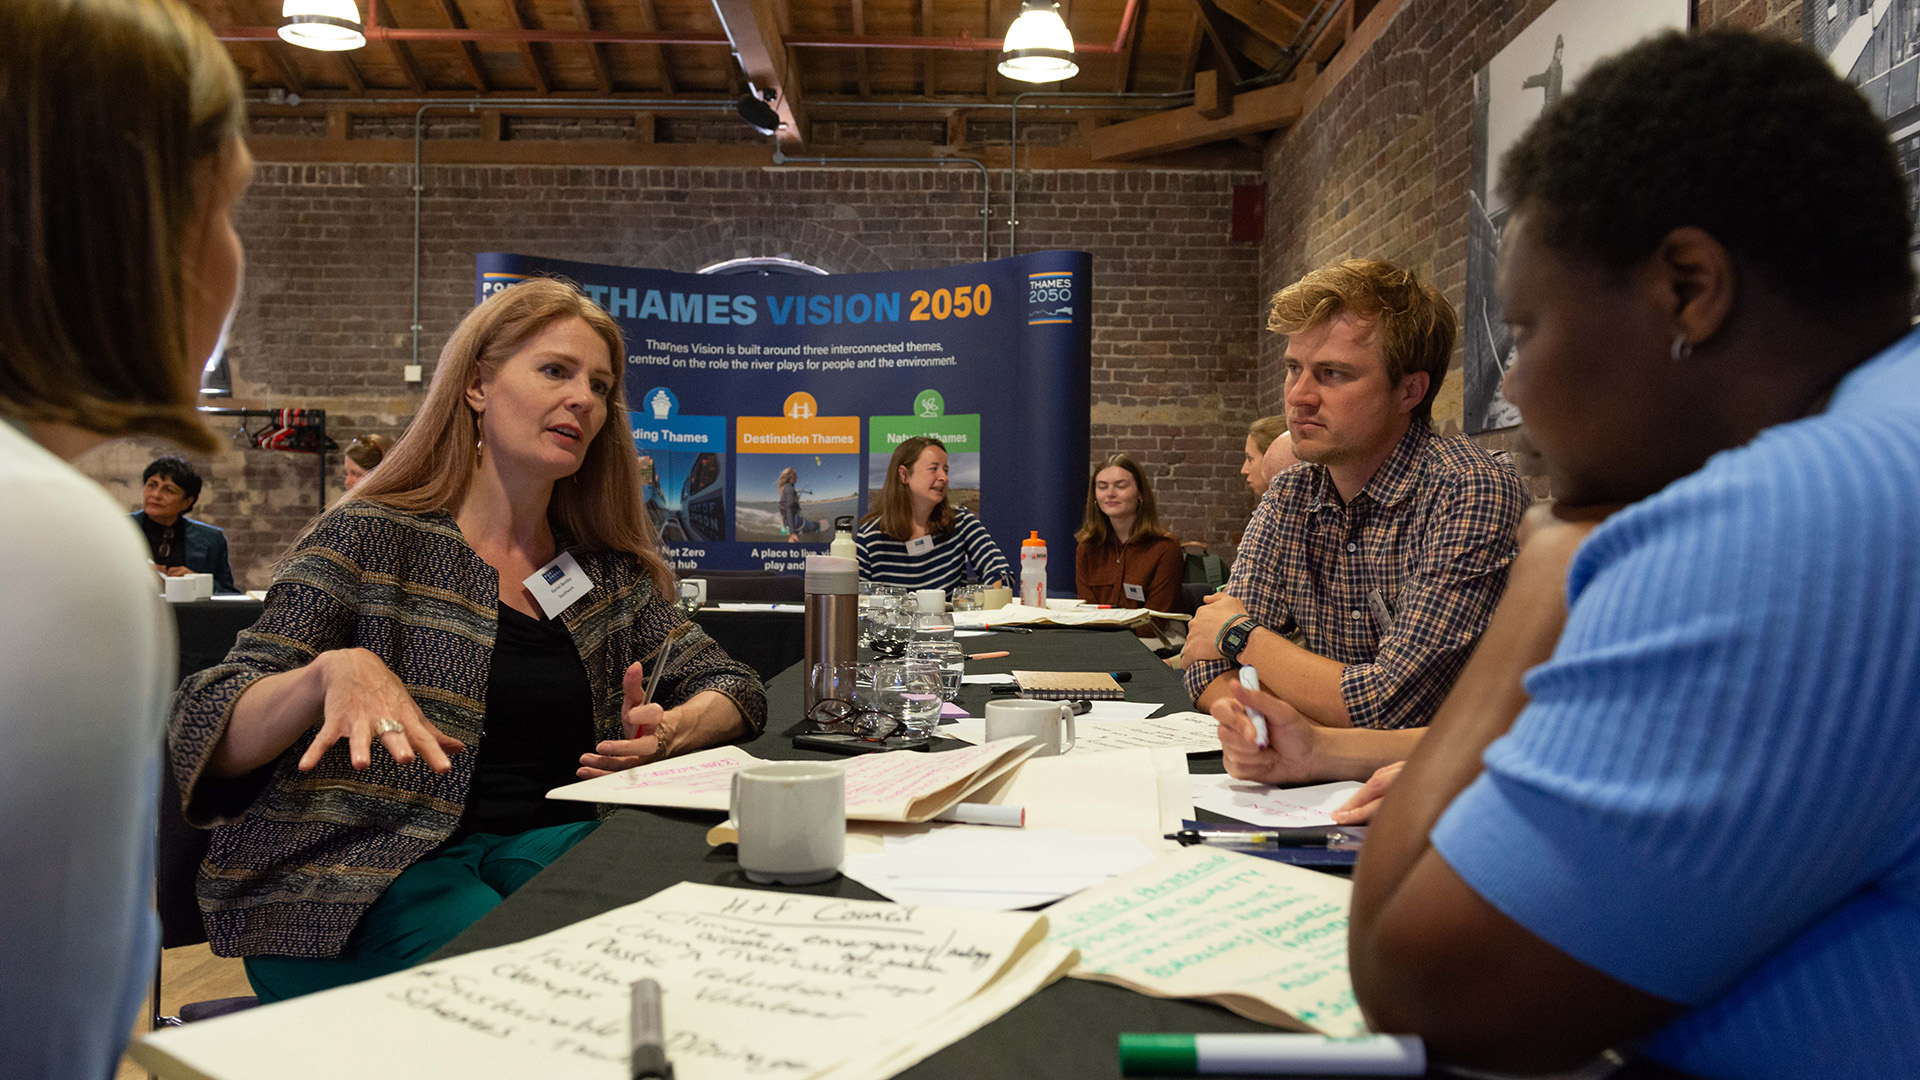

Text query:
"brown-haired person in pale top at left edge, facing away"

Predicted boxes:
[[0, 0, 253, 1060]]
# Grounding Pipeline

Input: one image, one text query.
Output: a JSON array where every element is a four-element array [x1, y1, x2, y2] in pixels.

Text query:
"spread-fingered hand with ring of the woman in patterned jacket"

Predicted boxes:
[[300, 650, 467, 773]]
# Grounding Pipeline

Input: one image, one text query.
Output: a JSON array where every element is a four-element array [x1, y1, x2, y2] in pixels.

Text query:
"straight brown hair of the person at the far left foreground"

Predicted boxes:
[[0, 0, 246, 454]]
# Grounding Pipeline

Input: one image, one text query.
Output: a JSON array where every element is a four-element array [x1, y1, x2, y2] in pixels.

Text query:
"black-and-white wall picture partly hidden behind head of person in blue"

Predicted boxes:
[[1461, 0, 1689, 434]]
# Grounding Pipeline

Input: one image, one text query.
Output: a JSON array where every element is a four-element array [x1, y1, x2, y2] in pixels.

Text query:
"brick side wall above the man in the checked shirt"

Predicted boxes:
[[1258, 0, 1801, 444]]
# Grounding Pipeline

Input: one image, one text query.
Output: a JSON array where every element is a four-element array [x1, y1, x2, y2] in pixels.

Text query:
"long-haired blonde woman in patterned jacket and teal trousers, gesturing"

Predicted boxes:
[[171, 281, 766, 1001]]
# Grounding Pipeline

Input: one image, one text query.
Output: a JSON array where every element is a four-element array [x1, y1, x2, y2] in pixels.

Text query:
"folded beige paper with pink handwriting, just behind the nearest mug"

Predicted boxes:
[[547, 736, 1039, 821]]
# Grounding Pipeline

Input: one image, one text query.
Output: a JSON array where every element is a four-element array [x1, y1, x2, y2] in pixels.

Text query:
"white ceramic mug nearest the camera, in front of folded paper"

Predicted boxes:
[[730, 761, 847, 886]]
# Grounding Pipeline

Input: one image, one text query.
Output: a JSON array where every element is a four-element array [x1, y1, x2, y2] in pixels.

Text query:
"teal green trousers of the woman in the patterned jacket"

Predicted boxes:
[[246, 821, 599, 1005]]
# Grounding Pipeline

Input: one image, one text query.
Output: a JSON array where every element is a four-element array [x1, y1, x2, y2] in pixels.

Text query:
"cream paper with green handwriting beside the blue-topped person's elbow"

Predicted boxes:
[[1046, 847, 1367, 1036]]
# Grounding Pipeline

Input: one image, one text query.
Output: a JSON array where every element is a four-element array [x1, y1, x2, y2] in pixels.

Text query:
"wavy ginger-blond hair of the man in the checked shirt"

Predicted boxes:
[[1261, 259, 1459, 424]]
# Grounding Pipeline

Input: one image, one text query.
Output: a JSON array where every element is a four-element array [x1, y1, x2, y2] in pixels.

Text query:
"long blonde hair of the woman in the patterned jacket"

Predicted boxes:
[[336, 279, 674, 596]]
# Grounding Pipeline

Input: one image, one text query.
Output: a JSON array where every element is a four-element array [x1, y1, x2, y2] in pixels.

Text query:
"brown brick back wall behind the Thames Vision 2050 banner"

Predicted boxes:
[[83, 163, 1260, 588]]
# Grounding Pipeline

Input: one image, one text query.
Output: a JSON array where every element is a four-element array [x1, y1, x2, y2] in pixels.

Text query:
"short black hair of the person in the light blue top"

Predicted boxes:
[[1501, 29, 1914, 319]]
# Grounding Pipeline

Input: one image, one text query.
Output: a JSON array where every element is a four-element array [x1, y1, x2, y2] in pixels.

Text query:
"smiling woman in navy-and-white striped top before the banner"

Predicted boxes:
[[854, 436, 1014, 590]]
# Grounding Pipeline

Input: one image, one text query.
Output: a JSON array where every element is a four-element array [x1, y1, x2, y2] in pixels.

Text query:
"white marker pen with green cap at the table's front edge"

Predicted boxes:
[[1119, 1032, 1427, 1076]]
